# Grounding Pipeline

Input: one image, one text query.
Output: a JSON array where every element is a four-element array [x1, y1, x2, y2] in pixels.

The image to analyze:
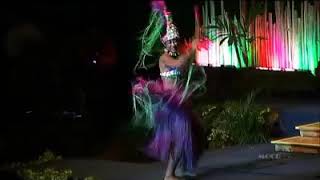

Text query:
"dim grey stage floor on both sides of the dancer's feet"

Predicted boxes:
[[8, 144, 320, 180]]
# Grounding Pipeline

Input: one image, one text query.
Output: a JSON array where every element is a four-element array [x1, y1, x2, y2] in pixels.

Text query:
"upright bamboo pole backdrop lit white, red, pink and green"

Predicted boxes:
[[197, 0, 320, 73]]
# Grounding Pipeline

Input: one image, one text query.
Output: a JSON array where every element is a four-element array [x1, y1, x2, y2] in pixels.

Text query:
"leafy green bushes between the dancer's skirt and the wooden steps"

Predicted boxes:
[[202, 93, 270, 148]]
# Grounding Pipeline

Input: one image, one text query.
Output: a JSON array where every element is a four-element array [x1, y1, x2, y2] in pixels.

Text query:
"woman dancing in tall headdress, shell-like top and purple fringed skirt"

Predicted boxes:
[[132, 1, 205, 180]]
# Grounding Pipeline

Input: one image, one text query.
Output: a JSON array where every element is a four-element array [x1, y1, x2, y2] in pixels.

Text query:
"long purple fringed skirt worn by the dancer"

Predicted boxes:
[[146, 97, 203, 169]]
